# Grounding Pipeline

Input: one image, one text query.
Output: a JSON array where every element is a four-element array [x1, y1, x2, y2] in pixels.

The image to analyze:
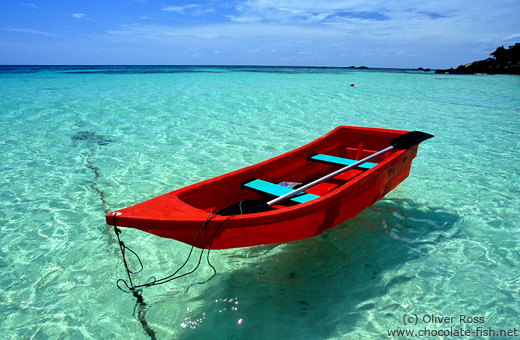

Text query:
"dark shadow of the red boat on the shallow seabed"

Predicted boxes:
[[142, 198, 464, 339]]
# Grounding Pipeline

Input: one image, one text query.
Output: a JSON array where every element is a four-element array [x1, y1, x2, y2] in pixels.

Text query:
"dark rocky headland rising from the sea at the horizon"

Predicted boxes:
[[435, 43, 520, 75]]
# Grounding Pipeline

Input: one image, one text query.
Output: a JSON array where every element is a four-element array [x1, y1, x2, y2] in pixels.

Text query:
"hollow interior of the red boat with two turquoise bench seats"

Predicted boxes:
[[179, 128, 399, 211]]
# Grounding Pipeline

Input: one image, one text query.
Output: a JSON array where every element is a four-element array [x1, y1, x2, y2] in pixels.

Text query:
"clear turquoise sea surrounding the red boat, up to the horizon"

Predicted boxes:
[[0, 67, 520, 339]]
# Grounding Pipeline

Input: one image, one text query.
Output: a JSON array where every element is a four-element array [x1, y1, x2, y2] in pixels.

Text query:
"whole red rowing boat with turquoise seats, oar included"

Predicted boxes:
[[106, 126, 433, 249]]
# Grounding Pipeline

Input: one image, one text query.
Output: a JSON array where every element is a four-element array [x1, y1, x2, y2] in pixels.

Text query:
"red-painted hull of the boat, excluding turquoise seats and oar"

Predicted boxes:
[[106, 127, 417, 249]]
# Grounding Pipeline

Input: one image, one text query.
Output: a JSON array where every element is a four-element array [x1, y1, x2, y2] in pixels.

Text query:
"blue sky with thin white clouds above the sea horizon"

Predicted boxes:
[[0, 0, 520, 68]]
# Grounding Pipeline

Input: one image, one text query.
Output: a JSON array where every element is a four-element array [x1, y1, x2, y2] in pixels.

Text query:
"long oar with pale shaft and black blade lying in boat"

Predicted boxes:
[[217, 131, 433, 215]]
